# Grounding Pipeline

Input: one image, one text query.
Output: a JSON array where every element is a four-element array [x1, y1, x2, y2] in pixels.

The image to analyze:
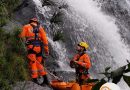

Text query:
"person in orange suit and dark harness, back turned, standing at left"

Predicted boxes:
[[19, 18, 49, 84]]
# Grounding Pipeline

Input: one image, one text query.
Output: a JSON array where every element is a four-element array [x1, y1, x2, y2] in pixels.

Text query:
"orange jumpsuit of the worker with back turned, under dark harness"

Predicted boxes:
[[19, 23, 49, 78]]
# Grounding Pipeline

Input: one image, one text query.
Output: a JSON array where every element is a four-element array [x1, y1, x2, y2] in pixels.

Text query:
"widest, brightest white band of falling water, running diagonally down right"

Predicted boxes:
[[68, 0, 130, 65]]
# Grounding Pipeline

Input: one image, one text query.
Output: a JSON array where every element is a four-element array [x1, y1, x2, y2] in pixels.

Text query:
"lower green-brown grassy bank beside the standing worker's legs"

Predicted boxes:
[[0, 28, 29, 90]]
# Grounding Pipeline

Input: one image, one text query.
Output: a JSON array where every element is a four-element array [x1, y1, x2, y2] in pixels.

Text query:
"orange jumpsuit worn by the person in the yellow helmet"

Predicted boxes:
[[72, 53, 91, 83]]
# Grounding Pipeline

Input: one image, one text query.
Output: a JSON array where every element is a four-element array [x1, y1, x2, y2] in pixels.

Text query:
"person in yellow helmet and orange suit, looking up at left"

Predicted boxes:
[[70, 42, 91, 85]]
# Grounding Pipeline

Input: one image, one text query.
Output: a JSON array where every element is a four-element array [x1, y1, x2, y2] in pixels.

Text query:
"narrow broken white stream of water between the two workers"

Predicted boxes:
[[33, 0, 73, 72]]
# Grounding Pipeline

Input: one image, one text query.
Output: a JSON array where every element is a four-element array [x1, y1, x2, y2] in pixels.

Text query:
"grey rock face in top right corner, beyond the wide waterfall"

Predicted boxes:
[[99, 0, 130, 45]]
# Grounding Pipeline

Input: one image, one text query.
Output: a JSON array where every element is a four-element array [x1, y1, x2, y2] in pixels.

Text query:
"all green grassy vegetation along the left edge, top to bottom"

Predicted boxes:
[[0, 0, 29, 90]]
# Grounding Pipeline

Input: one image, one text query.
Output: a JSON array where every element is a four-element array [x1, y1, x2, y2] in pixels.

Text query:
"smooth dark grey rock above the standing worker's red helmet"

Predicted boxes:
[[14, 0, 36, 24]]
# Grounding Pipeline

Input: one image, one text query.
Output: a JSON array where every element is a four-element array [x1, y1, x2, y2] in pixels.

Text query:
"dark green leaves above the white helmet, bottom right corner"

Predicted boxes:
[[92, 60, 130, 90]]
